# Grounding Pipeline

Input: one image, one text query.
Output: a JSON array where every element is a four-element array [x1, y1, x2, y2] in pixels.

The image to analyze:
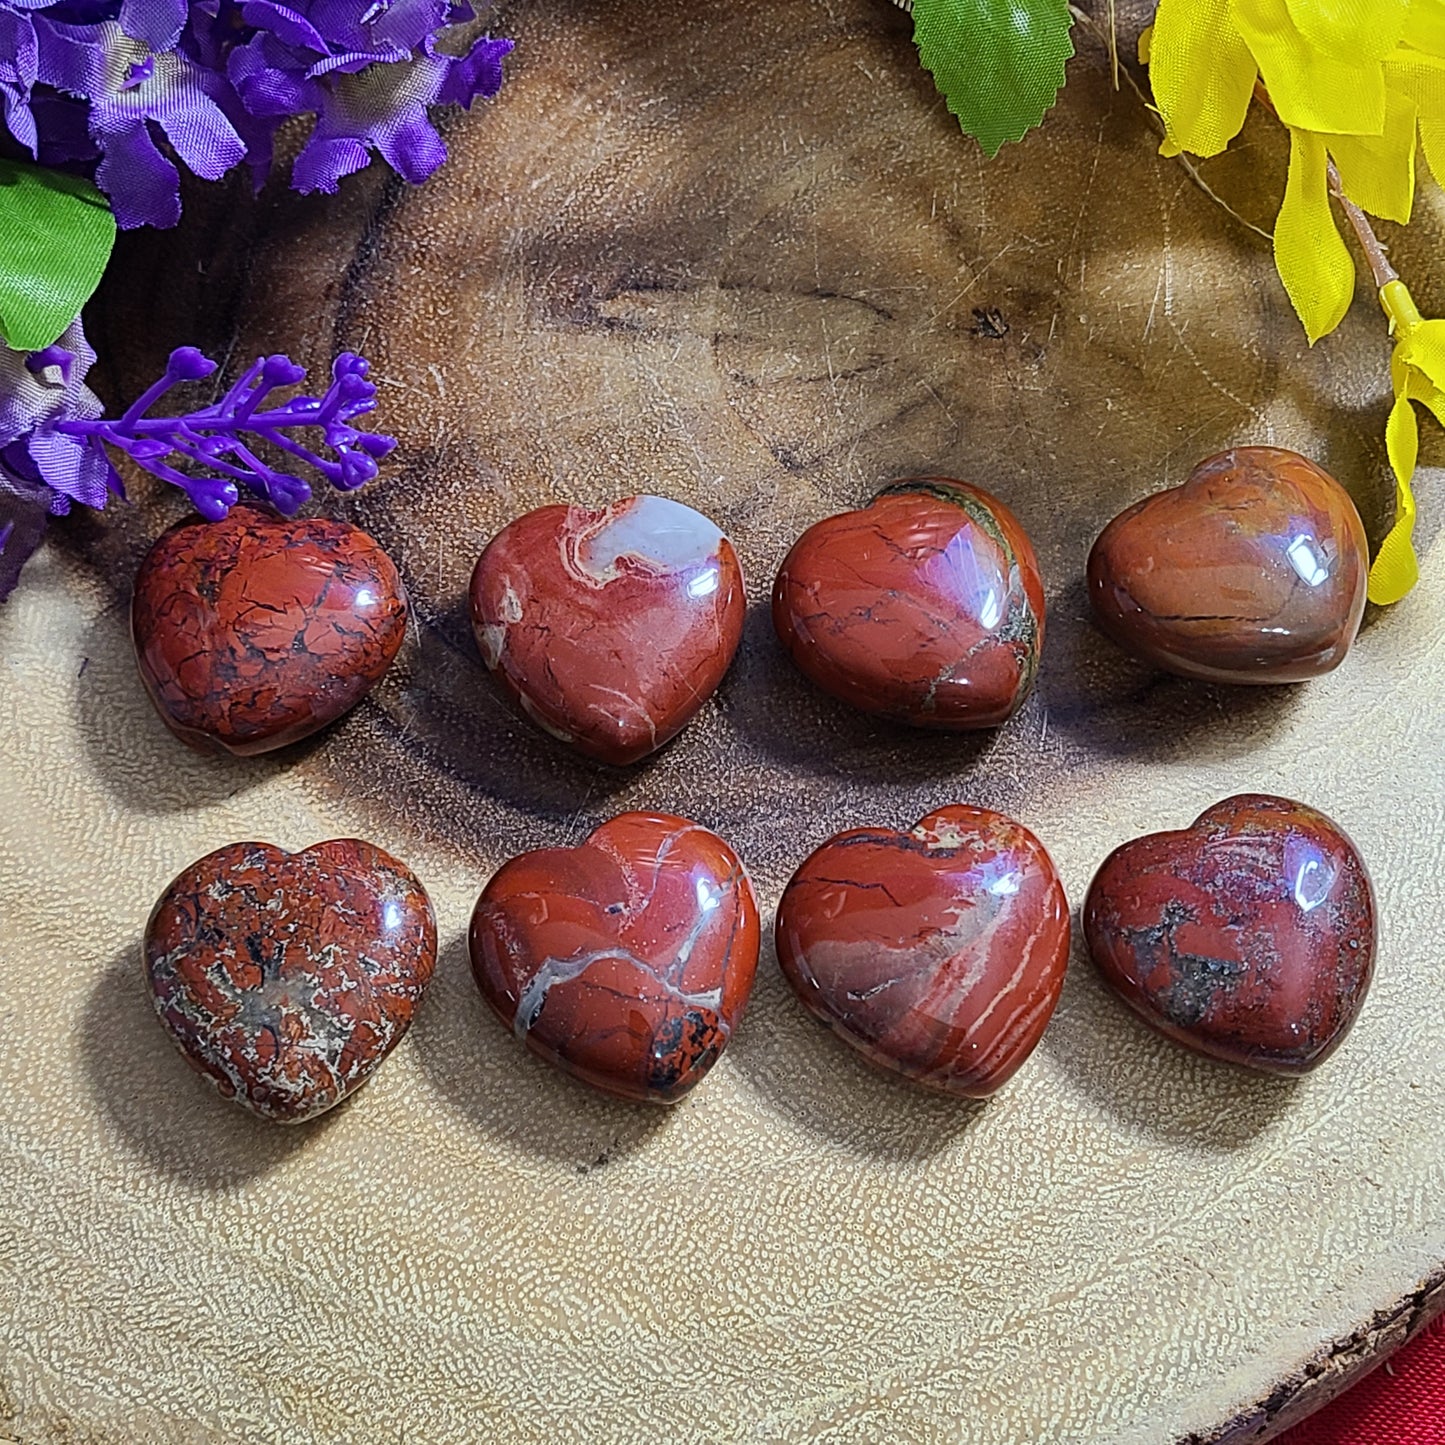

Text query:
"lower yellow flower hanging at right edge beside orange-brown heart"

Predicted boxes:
[[1370, 280, 1445, 604]]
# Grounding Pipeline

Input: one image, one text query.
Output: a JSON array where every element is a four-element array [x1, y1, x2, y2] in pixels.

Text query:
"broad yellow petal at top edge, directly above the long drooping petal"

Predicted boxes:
[[1236, 0, 1384, 136]]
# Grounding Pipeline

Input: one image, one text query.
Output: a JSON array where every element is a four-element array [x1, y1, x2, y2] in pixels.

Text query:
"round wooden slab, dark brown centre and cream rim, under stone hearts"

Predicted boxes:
[[0, 0, 1445, 1445]]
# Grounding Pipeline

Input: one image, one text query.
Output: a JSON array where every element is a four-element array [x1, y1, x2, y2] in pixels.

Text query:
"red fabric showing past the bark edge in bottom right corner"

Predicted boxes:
[[1277, 1318, 1445, 1445]]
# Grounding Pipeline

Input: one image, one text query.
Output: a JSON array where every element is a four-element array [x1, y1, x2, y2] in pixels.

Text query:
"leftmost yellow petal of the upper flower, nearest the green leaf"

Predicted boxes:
[[1149, 0, 1257, 156]]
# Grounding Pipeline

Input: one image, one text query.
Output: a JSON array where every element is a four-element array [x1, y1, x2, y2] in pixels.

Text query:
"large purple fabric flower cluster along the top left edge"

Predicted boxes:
[[0, 0, 512, 228]]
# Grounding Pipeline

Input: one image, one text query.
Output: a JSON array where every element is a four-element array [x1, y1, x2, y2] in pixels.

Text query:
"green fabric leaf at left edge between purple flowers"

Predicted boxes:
[[0, 160, 116, 351]]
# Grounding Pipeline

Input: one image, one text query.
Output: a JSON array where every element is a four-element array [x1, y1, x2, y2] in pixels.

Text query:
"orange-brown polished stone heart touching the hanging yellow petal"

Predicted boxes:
[[1088, 447, 1370, 682]]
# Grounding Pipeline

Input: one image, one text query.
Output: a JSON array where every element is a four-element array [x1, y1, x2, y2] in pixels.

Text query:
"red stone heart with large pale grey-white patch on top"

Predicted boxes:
[[471, 496, 747, 764]]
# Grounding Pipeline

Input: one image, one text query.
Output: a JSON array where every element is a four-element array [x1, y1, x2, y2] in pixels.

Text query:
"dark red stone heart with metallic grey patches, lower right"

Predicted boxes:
[[1084, 793, 1376, 1074]]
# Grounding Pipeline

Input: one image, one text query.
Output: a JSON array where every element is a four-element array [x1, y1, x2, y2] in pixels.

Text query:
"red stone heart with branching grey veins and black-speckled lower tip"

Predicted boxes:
[[471, 812, 759, 1104]]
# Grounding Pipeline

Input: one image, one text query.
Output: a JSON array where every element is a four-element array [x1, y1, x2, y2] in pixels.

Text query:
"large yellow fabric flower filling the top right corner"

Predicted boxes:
[[1149, 0, 1445, 344]]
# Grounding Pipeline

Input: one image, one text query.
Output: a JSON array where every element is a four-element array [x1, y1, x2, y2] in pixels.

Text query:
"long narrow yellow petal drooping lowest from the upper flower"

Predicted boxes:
[[1274, 130, 1354, 345]]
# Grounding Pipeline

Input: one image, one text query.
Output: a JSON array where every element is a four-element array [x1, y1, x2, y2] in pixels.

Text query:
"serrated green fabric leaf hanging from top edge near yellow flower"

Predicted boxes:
[[913, 0, 1074, 156]]
